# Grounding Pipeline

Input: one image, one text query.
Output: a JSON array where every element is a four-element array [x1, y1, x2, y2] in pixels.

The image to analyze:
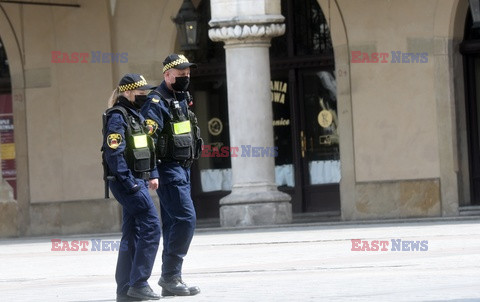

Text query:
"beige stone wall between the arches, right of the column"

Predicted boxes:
[[322, 1, 468, 220]]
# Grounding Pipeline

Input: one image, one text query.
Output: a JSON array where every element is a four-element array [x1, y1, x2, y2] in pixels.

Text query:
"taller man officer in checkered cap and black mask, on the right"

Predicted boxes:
[[141, 54, 201, 296]]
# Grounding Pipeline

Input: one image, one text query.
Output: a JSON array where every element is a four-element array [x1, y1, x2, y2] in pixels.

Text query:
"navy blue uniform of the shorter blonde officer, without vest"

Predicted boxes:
[[103, 97, 161, 295]]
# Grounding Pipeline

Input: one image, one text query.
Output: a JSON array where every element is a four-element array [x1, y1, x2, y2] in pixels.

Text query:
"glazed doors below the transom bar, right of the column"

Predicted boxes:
[[272, 66, 341, 213]]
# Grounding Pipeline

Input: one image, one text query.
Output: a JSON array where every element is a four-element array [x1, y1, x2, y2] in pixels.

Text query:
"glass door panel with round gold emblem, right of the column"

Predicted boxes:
[[298, 69, 341, 212]]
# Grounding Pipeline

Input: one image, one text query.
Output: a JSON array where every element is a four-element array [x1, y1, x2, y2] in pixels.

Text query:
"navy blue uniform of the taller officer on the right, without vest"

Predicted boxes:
[[141, 81, 196, 278]]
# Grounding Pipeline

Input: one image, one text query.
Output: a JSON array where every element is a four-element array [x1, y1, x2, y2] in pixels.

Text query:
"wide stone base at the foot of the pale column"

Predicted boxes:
[[220, 191, 292, 227]]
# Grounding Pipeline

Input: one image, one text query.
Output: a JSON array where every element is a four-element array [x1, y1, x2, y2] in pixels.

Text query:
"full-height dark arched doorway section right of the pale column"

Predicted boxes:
[[270, 0, 341, 215]]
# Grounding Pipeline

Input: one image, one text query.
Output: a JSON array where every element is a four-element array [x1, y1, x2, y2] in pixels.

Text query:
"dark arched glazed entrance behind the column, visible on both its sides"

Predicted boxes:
[[191, 0, 341, 218]]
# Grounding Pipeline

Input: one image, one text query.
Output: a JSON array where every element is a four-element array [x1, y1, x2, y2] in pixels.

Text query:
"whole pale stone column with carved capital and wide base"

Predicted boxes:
[[209, 0, 292, 227]]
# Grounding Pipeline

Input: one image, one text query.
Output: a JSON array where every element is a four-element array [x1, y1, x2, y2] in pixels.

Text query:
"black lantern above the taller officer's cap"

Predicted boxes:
[[172, 0, 200, 51]]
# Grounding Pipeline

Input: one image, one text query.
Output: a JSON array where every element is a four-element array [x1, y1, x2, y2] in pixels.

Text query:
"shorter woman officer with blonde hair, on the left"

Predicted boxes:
[[103, 74, 161, 301]]
